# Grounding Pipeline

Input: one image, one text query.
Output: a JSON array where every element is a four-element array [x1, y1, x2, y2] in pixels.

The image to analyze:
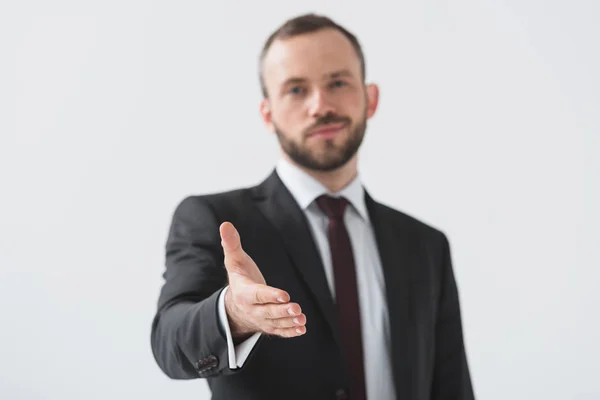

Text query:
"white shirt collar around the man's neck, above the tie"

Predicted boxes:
[[275, 158, 369, 221]]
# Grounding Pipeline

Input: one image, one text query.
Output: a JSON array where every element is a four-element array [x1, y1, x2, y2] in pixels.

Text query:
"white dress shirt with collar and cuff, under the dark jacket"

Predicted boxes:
[[219, 159, 395, 400]]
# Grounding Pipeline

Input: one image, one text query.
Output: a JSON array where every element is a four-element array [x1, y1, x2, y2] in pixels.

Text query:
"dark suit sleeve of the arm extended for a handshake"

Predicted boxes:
[[151, 197, 258, 379]]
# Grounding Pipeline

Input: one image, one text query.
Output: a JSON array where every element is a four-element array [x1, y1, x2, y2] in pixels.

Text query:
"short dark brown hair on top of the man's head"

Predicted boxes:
[[258, 13, 366, 98]]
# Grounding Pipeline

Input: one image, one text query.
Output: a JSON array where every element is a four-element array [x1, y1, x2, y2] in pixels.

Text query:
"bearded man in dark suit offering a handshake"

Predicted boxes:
[[152, 14, 474, 400]]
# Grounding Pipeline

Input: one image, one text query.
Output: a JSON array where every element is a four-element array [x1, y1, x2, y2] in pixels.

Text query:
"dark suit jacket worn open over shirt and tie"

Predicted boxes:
[[151, 172, 474, 400]]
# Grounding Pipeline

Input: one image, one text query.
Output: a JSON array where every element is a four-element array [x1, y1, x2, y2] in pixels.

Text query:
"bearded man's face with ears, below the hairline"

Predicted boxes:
[[261, 29, 377, 171]]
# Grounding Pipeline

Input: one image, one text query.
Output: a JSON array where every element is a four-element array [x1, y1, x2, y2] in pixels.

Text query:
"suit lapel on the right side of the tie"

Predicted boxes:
[[365, 192, 417, 399]]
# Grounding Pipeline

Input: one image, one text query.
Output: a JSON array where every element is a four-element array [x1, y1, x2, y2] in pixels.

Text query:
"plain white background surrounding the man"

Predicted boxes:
[[0, 0, 600, 400]]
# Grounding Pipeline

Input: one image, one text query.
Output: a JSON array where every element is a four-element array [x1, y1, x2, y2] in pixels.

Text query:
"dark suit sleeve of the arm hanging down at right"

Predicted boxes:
[[431, 235, 475, 400]]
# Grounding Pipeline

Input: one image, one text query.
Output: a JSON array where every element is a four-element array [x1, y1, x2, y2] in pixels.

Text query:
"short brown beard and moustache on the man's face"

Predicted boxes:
[[273, 110, 367, 172]]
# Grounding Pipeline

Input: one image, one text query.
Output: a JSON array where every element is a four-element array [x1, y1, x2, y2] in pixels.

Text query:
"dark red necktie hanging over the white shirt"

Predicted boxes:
[[317, 196, 367, 400]]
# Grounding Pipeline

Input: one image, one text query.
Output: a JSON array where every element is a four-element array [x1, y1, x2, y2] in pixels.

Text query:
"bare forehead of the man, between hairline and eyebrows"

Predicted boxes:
[[263, 30, 360, 83]]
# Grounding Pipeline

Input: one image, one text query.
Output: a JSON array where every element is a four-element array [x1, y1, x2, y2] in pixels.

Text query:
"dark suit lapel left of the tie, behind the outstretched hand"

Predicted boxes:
[[254, 172, 342, 348]]
